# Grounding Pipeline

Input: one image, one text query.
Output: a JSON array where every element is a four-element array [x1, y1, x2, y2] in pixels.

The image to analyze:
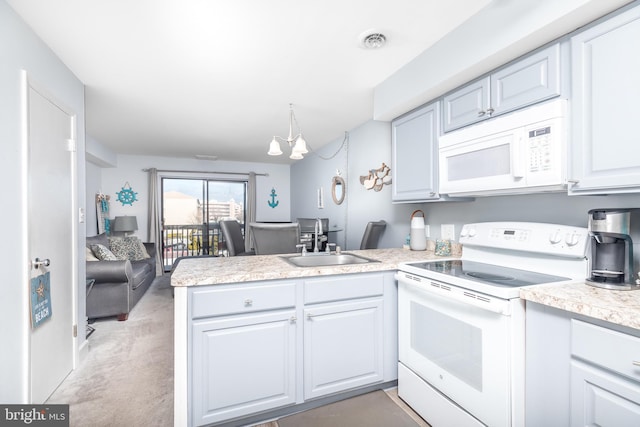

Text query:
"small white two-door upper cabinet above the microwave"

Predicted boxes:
[[443, 43, 561, 132]]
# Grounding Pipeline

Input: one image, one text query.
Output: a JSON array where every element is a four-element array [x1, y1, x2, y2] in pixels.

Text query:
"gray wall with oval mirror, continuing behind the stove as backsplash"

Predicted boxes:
[[291, 117, 640, 249]]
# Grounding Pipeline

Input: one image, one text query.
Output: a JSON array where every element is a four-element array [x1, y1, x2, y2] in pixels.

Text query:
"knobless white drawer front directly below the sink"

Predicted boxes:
[[304, 274, 384, 304]]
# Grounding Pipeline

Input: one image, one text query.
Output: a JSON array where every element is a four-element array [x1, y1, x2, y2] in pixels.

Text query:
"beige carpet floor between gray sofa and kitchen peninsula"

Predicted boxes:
[[47, 275, 173, 427]]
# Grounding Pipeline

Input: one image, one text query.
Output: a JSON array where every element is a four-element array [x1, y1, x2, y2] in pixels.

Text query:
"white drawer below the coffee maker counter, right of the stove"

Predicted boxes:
[[571, 319, 640, 381]]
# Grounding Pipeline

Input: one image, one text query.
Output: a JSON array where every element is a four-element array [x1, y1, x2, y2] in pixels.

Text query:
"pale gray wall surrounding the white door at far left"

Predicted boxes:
[[0, 0, 85, 403]]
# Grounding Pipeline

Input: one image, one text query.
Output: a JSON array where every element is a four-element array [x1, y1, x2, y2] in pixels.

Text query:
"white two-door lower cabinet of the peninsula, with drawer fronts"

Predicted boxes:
[[186, 272, 397, 426]]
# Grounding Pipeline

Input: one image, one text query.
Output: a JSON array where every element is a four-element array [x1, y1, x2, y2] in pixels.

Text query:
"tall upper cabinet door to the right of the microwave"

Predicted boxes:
[[569, 7, 640, 194]]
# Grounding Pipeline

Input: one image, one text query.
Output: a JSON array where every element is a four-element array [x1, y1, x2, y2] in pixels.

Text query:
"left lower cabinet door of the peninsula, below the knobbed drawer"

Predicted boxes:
[[189, 310, 296, 425]]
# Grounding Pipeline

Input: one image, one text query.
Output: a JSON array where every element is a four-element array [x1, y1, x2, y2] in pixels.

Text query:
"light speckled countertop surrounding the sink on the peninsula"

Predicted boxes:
[[171, 248, 438, 286]]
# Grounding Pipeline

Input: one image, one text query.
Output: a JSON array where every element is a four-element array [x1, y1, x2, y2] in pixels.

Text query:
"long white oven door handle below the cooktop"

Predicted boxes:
[[396, 275, 511, 316]]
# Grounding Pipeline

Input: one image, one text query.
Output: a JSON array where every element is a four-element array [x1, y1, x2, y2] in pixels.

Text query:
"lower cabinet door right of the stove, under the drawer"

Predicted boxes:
[[571, 360, 640, 427]]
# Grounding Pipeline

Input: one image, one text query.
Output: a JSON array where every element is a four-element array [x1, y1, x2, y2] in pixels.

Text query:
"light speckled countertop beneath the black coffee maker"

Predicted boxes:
[[520, 283, 640, 329]]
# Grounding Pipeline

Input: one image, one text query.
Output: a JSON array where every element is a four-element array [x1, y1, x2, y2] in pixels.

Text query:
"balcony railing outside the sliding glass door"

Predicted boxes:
[[162, 222, 226, 271]]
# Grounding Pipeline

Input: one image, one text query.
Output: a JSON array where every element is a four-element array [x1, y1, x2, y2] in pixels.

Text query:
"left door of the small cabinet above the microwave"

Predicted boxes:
[[443, 77, 491, 132]]
